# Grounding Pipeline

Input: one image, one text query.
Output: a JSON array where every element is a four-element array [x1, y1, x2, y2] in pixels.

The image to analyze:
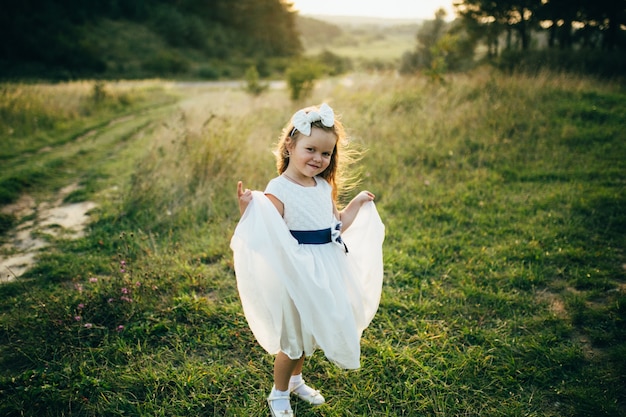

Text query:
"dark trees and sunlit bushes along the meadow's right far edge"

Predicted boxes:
[[400, 0, 626, 78]]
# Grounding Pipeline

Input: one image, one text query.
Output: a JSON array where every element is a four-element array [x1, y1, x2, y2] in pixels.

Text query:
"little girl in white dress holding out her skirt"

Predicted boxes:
[[231, 104, 385, 417]]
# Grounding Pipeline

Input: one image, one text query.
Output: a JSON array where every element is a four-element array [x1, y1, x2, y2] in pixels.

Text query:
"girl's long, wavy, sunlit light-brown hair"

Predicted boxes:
[[275, 106, 361, 203]]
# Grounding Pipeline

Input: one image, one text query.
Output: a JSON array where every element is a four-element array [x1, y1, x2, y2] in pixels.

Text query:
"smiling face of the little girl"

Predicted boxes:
[[285, 127, 337, 180]]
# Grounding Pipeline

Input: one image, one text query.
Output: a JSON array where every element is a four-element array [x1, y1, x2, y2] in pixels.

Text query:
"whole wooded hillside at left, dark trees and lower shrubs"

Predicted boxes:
[[0, 0, 301, 78]]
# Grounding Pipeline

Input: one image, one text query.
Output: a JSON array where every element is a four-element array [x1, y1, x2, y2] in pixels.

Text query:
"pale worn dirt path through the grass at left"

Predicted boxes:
[[0, 98, 178, 283]]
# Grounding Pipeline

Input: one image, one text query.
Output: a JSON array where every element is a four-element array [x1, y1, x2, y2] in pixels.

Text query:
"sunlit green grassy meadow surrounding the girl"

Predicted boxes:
[[0, 68, 626, 417]]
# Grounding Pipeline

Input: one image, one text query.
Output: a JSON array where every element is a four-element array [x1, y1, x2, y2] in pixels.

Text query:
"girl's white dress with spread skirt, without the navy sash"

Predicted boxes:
[[231, 176, 385, 369]]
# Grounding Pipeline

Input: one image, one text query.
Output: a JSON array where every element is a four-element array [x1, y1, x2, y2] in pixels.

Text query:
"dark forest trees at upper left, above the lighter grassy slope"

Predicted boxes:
[[0, 0, 301, 79]]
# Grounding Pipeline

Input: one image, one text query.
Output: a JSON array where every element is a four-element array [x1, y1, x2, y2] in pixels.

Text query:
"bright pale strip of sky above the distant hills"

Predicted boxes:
[[290, 0, 454, 19]]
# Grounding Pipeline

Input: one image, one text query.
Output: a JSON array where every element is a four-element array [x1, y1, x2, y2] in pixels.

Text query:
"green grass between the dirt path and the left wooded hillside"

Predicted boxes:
[[0, 81, 178, 204]]
